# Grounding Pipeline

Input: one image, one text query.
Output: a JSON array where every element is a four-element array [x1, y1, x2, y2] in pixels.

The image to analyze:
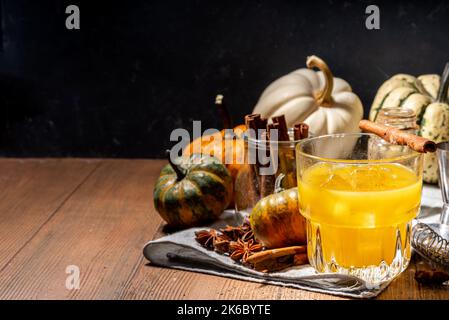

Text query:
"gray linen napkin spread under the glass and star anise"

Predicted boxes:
[[143, 186, 441, 298]]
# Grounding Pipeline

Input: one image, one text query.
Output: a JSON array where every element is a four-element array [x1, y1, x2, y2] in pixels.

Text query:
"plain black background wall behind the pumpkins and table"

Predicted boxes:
[[0, 0, 449, 157]]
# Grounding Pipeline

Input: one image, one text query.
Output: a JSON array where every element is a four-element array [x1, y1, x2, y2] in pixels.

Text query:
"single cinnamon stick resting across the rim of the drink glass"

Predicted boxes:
[[359, 120, 437, 153]]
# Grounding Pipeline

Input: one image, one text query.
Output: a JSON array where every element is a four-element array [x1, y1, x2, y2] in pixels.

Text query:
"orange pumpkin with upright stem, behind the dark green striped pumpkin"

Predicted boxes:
[[183, 95, 246, 207]]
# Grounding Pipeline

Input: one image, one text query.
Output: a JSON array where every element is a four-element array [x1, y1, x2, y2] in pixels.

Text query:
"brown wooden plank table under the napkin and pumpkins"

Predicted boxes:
[[0, 159, 449, 299]]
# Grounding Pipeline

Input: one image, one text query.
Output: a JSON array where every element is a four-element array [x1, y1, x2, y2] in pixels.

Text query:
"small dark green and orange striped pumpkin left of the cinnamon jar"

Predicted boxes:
[[153, 154, 232, 228]]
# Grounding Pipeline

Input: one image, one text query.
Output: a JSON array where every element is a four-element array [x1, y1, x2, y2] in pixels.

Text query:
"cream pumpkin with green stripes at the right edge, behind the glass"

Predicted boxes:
[[369, 63, 449, 183]]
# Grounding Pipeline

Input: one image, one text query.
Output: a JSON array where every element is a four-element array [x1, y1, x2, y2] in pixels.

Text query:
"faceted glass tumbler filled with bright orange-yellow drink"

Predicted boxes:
[[296, 133, 422, 284]]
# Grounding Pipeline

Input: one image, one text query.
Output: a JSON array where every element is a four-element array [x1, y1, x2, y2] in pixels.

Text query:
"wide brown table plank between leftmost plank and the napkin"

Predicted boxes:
[[0, 160, 162, 299]]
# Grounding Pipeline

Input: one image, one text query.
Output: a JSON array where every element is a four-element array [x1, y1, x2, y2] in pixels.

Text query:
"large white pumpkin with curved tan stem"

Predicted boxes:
[[253, 56, 363, 135]]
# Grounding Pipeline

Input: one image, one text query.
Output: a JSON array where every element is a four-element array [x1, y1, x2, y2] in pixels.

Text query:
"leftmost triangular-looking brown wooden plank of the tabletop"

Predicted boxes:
[[0, 159, 98, 271]]
